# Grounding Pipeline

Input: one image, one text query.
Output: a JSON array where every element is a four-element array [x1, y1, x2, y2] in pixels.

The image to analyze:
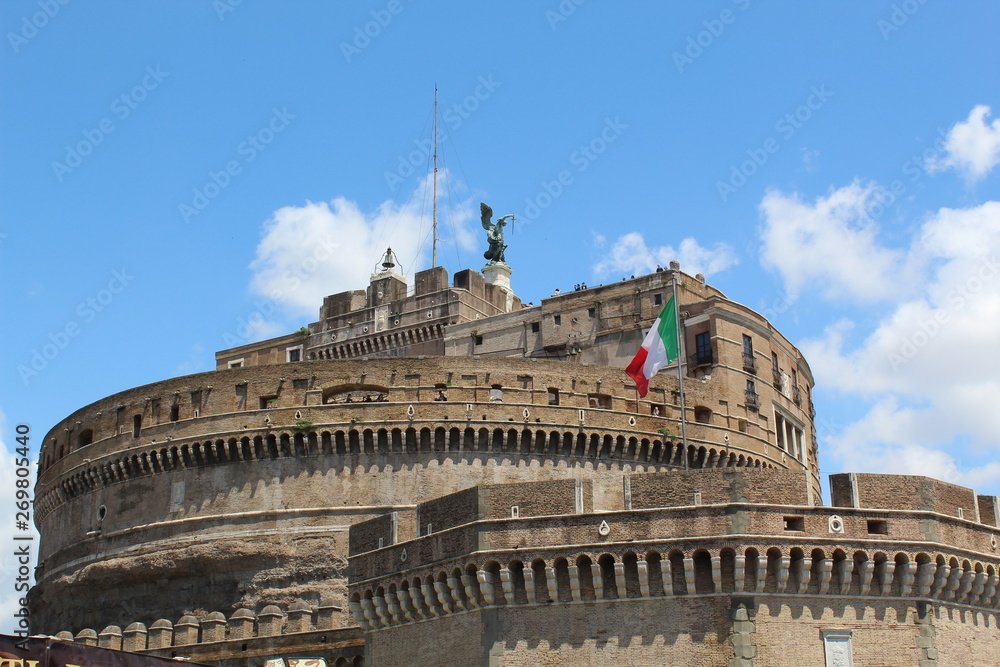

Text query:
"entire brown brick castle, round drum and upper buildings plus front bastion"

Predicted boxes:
[[30, 252, 1000, 667]]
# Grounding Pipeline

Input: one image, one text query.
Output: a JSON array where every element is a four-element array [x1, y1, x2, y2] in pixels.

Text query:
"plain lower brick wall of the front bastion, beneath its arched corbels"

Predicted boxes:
[[365, 595, 1000, 667]]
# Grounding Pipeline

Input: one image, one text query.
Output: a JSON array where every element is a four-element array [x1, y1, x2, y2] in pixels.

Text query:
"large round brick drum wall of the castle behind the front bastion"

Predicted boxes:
[[32, 357, 818, 631]]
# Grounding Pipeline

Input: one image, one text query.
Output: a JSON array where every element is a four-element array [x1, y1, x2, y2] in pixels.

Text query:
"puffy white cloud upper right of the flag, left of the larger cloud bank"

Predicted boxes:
[[760, 181, 910, 302]]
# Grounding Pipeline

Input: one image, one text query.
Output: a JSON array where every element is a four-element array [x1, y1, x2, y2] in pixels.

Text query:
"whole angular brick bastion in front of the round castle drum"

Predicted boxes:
[[350, 470, 1000, 667]]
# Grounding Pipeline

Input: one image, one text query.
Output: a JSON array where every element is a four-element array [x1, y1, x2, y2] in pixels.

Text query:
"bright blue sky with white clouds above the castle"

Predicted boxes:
[[0, 0, 1000, 628]]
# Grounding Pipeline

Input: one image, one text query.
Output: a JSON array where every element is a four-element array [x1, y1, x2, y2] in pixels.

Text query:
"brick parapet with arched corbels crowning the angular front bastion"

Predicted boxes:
[[350, 470, 1000, 631]]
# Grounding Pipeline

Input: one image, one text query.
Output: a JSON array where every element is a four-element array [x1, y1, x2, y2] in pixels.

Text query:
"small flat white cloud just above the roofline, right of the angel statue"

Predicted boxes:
[[594, 232, 739, 277]]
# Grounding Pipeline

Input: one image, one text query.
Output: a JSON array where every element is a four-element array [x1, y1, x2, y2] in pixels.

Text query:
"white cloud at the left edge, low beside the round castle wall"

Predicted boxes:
[[0, 410, 38, 635]]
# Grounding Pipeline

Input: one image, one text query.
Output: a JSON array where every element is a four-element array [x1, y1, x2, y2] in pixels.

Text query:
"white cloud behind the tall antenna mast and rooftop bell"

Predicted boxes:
[[246, 171, 478, 324]]
